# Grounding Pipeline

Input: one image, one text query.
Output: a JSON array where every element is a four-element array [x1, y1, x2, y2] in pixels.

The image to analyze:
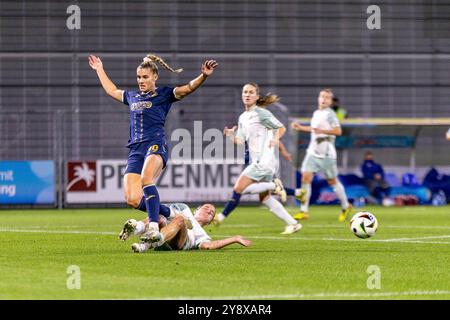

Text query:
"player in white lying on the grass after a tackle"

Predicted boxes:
[[119, 203, 251, 253]]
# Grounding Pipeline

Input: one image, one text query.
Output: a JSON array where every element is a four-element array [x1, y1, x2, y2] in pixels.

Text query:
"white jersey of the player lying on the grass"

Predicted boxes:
[[169, 203, 211, 250]]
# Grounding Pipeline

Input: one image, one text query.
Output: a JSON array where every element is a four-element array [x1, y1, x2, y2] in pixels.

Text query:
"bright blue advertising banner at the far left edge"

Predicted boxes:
[[0, 160, 55, 204]]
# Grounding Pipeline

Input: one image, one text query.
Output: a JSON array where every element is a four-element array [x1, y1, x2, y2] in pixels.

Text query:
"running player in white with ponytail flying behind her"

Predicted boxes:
[[215, 83, 301, 234]]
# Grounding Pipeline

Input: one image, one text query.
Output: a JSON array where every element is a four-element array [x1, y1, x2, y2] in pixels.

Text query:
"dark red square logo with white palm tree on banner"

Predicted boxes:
[[67, 161, 97, 192]]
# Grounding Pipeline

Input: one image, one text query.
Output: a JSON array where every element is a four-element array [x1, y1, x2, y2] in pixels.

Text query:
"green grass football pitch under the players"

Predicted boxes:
[[0, 206, 450, 300]]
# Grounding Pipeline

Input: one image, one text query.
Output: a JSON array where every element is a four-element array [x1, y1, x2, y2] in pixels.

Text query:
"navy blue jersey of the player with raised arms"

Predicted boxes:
[[123, 87, 178, 146]]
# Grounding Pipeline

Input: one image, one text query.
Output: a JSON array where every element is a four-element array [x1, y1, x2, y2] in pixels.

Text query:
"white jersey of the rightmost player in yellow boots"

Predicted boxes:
[[307, 108, 340, 159]]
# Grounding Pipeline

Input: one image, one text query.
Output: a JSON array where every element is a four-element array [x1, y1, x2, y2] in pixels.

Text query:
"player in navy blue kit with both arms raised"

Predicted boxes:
[[89, 55, 218, 237]]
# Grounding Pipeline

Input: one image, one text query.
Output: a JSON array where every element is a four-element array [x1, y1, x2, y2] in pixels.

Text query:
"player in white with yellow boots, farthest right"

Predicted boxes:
[[292, 89, 352, 222]]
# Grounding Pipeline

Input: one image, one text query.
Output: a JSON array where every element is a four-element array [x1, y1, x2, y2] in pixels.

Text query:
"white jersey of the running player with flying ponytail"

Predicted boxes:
[[236, 106, 283, 172]]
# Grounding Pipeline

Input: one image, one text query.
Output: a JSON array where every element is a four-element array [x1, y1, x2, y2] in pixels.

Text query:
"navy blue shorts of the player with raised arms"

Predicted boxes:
[[125, 141, 169, 174]]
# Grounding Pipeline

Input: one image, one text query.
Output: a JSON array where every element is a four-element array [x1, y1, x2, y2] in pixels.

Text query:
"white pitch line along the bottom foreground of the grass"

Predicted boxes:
[[139, 290, 450, 300]]
